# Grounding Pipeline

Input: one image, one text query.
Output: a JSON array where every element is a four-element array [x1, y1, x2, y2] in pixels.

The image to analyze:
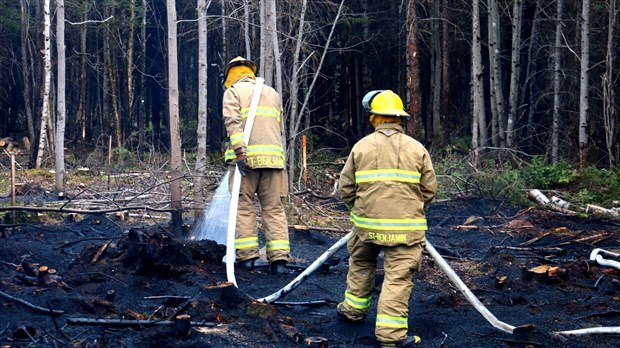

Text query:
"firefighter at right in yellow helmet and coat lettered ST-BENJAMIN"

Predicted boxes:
[[337, 90, 437, 347]]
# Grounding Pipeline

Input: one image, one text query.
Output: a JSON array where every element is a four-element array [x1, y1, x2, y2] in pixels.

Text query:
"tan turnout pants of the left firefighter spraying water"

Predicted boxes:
[[229, 169, 290, 263]]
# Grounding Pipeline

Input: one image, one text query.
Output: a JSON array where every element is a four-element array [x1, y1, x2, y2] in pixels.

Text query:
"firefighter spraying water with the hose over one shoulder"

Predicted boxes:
[[223, 57, 290, 273]]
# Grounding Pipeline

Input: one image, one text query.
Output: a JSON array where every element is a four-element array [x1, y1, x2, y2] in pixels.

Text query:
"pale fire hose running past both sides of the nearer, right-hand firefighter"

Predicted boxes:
[[258, 232, 534, 334]]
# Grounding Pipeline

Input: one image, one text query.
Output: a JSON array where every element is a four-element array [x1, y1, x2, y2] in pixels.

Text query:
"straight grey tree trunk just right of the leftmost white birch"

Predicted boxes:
[[55, 0, 66, 192]]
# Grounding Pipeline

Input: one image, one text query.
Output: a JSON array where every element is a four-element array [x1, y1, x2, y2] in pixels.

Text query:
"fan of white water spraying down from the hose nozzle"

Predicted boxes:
[[188, 173, 230, 245]]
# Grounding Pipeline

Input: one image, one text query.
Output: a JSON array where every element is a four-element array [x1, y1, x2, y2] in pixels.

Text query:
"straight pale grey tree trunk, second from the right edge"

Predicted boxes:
[[579, 0, 590, 168]]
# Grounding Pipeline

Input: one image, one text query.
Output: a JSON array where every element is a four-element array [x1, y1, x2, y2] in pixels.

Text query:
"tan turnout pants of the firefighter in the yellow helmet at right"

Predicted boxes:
[[342, 234, 423, 343]]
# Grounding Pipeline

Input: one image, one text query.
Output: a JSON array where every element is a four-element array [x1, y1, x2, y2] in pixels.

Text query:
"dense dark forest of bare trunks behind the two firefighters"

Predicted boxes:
[[0, 0, 620, 232]]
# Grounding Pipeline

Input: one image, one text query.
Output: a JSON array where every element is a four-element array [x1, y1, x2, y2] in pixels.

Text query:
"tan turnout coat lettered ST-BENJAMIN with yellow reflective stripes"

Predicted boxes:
[[339, 123, 437, 246]]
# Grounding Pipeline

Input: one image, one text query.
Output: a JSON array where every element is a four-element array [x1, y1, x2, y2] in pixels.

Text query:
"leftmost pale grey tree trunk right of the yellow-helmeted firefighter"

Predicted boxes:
[[471, 0, 487, 165]]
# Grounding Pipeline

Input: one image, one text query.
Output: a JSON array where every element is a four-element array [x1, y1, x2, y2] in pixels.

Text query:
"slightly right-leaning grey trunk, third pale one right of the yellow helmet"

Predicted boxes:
[[506, 0, 523, 148]]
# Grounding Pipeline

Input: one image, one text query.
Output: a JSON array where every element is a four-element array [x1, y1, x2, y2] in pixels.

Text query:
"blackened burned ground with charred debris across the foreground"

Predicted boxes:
[[0, 190, 620, 347]]
